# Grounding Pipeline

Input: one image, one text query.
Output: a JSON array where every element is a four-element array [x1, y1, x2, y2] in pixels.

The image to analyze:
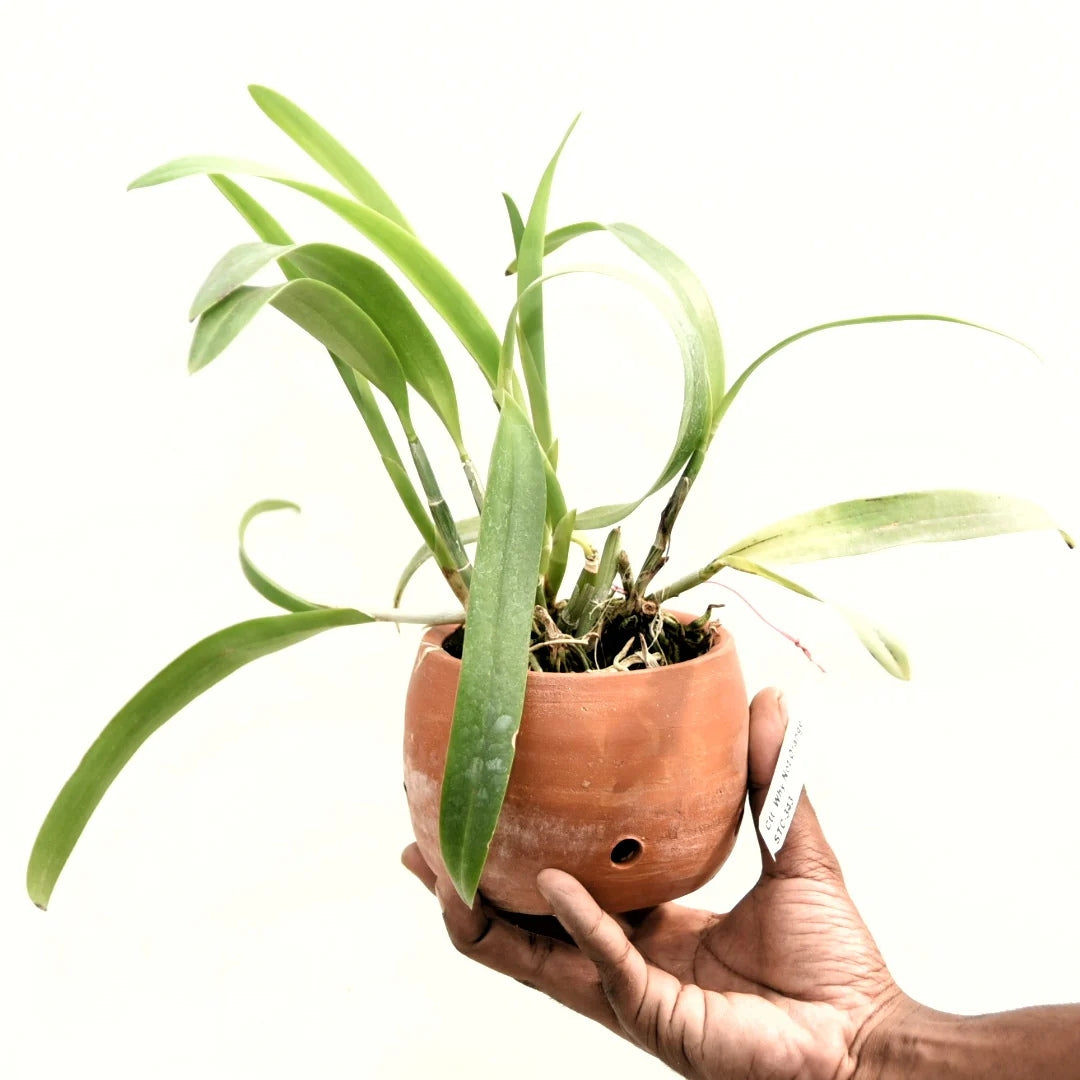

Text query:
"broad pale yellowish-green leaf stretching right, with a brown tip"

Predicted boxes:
[[720, 490, 1071, 564]]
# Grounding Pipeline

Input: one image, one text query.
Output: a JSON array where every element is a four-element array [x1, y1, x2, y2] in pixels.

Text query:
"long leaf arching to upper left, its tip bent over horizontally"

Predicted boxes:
[[127, 164, 499, 387]]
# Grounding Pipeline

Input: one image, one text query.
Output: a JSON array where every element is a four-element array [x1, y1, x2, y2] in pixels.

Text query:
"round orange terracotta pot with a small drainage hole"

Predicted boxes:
[[405, 626, 750, 915]]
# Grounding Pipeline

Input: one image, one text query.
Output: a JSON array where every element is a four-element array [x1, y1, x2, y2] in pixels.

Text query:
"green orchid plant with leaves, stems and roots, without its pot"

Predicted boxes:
[[27, 86, 1072, 907]]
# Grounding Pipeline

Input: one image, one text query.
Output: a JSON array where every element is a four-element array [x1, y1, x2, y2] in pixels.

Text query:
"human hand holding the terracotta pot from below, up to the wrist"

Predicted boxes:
[[402, 690, 919, 1080]]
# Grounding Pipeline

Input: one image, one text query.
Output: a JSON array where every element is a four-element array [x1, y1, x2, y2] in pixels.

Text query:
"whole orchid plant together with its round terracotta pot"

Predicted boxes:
[[27, 86, 1071, 912]]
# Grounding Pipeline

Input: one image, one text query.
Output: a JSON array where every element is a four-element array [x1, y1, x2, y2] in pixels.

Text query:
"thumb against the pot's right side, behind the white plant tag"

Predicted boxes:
[[747, 689, 843, 883]]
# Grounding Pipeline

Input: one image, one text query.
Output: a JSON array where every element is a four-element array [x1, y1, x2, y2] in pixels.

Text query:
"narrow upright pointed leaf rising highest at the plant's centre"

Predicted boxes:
[[517, 113, 581, 447]]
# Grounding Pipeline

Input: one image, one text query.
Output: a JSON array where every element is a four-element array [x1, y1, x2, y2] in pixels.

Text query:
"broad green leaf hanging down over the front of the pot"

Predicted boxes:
[[440, 400, 545, 904]]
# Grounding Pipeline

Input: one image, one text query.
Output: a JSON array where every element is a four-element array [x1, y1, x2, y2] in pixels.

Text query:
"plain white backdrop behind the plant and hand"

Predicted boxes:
[[0, 0, 1080, 1080]]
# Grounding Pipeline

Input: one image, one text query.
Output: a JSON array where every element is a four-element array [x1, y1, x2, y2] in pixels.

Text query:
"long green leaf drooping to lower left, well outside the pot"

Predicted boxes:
[[26, 608, 372, 908]]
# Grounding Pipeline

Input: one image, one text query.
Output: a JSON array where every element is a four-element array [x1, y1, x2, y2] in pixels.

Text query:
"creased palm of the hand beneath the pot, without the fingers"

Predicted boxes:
[[609, 842, 890, 1080]]
